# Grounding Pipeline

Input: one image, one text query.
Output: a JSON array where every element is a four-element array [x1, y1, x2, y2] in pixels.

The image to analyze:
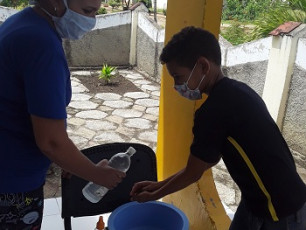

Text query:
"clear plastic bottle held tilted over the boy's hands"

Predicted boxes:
[[82, 147, 136, 203]]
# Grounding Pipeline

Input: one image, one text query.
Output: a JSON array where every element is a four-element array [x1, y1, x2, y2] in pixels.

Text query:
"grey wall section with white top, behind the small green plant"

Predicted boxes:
[[63, 11, 132, 67]]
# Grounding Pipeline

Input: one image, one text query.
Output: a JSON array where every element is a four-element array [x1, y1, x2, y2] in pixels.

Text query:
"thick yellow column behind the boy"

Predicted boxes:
[[157, 0, 230, 230]]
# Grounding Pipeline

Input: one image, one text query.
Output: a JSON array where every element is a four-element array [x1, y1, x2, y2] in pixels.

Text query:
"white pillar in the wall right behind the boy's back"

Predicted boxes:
[[262, 24, 306, 129]]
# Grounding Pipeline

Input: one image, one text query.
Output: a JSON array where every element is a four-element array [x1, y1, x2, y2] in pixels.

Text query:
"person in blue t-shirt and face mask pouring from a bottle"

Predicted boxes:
[[0, 0, 125, 229]]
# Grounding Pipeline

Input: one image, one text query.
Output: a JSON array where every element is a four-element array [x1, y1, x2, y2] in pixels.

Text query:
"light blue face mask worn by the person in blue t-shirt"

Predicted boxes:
[[41, 0, 96, 40]]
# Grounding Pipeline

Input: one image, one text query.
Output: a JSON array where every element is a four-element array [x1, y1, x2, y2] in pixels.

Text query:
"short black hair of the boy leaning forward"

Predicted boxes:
[[160, 26, 221, 68]]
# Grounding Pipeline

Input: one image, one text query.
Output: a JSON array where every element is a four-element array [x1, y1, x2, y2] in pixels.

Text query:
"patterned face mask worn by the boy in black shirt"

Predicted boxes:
[[174, 63, 205, 100]]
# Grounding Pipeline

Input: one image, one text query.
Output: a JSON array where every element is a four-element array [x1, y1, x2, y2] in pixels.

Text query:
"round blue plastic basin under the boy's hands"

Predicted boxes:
[[108, 201, 189, 230]]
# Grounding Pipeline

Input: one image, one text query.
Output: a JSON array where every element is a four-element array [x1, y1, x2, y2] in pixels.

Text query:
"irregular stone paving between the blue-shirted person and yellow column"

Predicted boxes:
[[67, 70, 160, 151]]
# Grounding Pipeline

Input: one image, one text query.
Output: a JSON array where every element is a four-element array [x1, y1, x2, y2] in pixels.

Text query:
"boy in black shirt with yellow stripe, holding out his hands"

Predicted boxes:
[[131, 27, 306, 230]]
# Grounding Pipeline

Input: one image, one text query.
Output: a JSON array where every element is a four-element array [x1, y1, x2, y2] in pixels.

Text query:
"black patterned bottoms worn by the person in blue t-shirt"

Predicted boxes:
[[0, 186, 44, 230]]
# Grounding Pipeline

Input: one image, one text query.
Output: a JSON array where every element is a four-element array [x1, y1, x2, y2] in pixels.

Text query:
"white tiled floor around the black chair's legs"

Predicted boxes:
[[41, 197, 110, 230]]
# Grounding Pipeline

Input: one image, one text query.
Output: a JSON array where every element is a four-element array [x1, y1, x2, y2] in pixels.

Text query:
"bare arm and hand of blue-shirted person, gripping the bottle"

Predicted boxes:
[[31, 115, 125, 189]]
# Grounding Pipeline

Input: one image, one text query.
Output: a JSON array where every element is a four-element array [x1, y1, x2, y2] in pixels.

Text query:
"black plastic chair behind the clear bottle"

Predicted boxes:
[[62, 143, 157, 230]]
